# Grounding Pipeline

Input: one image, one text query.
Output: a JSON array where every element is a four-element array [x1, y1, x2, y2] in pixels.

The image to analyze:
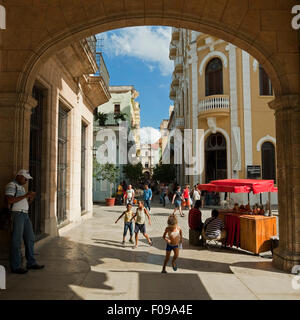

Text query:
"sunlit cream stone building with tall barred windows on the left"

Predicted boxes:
[[2, 37, 110, 241]]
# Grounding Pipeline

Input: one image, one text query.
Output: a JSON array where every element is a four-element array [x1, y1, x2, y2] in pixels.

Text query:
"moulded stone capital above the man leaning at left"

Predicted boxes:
[[0, 92, 38, 111]]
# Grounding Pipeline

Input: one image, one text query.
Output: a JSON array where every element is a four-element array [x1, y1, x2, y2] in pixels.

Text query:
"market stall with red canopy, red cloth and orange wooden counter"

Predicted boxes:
[[198, 179, 277, 254]]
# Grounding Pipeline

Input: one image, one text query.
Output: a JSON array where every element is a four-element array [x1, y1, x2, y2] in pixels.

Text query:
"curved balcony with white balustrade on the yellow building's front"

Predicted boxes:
[[198, 95, 230, 118]]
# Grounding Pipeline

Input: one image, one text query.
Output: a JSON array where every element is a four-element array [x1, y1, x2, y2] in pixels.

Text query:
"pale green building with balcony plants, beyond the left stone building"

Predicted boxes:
[[93, 86, 141, 201]]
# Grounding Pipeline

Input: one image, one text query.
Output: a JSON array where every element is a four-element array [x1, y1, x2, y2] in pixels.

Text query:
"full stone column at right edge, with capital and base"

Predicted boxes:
[[269, 95, 300, 271]]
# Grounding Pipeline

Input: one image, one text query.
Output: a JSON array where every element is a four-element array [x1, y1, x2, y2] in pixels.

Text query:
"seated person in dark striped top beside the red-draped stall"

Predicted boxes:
[[202, 209, 226, 244]]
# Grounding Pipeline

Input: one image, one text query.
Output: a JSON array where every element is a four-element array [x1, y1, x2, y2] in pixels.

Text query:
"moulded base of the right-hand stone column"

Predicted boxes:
[[272, 248, 300, 272]]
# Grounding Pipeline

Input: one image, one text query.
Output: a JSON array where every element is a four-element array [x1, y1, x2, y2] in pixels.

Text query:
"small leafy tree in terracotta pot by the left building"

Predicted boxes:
[[94, 160, 119, 206]]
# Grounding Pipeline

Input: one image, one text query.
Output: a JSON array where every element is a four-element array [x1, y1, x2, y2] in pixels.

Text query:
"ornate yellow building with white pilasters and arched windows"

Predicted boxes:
[[170, 28, 277, 205]]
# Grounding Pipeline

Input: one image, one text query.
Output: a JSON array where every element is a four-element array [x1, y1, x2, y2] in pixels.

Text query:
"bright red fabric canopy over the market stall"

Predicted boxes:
[[198, 179, 277, 194]]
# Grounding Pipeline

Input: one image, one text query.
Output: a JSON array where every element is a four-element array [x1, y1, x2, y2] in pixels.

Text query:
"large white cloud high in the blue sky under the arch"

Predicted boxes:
[[98, 26, 173, 76]]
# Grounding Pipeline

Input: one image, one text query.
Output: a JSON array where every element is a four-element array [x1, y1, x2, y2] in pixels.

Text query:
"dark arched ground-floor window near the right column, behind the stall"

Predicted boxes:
[[261, 141, 276, 183]]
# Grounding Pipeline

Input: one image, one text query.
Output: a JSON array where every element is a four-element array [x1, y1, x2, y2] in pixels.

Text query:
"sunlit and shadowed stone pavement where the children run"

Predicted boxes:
[[0, 204, 300, 300]]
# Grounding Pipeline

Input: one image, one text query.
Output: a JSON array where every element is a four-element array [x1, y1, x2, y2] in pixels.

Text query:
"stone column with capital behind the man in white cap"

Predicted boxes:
[[0, 93, 37, 200]]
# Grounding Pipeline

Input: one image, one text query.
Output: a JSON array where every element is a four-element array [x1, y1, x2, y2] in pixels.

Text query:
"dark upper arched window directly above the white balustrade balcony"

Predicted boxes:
[[205, 58, 223, 96]]
